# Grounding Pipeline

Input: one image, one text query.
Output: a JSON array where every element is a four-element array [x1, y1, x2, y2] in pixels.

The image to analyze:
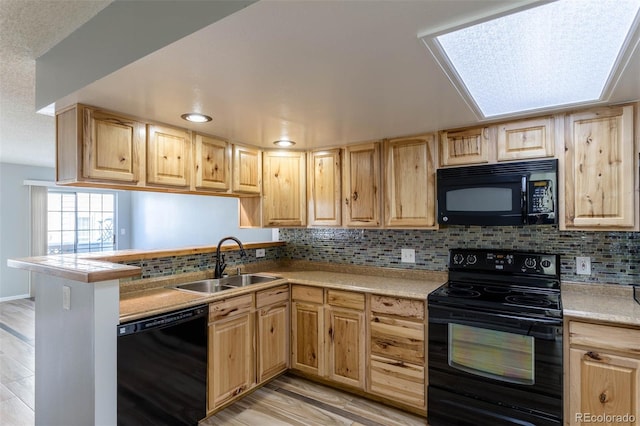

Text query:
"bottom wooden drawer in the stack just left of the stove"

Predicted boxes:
[[370, 356, 425, 409]]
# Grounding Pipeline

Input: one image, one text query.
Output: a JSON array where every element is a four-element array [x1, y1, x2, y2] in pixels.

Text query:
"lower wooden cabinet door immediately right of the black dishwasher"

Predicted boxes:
[[208, 312, 254, 411]]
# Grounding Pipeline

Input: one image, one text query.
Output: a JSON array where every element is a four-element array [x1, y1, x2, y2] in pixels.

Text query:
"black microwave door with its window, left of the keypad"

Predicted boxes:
[[438, 169, 527, 225]]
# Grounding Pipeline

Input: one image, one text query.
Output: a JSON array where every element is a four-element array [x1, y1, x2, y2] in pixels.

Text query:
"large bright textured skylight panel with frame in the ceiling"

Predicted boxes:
[[420, 0, 640, 118]]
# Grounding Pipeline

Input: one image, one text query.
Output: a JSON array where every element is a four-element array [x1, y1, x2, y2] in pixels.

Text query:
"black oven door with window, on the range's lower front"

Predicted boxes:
[[428, 304, 562, 426]]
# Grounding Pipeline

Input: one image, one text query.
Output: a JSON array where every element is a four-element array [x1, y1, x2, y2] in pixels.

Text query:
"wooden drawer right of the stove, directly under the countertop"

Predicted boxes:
[[569, 321, 640, 356]]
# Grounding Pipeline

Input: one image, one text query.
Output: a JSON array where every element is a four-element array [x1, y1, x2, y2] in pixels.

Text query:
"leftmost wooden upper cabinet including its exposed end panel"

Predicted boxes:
[[56, 105, 146, 185]]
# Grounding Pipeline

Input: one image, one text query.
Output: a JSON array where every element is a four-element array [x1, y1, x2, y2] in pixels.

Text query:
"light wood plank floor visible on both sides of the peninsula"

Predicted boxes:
[[0, 299, 426, 426]]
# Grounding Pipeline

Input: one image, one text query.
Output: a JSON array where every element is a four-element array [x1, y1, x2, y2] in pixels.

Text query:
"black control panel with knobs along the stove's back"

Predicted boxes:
[[449, 249, 560, 277]]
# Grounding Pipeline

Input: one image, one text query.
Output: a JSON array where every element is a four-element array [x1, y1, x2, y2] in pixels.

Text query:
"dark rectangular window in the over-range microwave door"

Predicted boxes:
[[447, 187, 513, 212]]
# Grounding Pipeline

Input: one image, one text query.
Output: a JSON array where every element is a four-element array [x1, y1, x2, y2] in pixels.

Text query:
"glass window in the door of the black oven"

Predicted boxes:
[[449, 323, 535, 385]]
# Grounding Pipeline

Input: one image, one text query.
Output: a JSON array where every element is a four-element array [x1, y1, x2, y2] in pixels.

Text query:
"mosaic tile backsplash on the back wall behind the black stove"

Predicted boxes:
[[280, 226, 640, 284]]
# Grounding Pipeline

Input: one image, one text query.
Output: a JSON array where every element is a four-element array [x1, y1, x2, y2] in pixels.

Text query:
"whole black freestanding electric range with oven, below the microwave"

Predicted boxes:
[[427, 249, 563, 426]]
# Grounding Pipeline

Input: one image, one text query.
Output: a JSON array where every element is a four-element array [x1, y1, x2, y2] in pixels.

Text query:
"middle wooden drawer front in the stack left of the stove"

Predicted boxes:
[[370, 315, 425, 366]]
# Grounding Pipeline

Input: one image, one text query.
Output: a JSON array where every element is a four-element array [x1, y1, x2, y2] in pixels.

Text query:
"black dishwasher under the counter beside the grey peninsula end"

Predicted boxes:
[[117, 305, 209, 426]]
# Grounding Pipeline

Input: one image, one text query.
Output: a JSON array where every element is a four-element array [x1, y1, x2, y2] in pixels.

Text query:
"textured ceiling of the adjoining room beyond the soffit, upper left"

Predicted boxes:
[[0, 0, 111, 167]]
